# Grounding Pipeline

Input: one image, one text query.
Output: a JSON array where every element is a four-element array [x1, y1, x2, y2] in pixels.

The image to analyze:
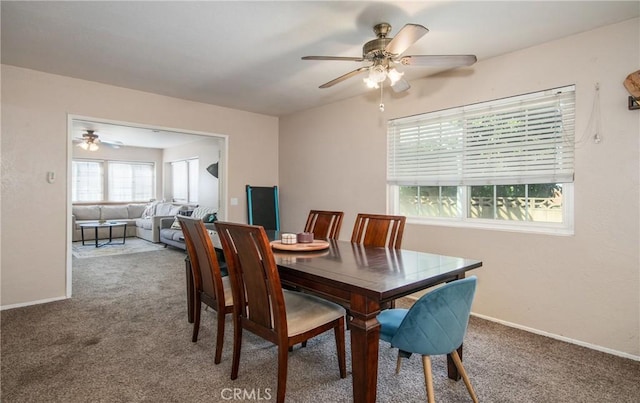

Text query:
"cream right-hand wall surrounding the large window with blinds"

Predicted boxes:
[[280, 19, 640, 358]]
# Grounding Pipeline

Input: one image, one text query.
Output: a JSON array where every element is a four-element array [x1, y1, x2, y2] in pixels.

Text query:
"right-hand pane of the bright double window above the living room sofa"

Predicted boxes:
[[108, 161, 154, 202]]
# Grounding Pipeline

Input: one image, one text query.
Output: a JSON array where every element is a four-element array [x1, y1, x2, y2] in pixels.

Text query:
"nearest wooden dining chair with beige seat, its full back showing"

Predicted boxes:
[[216, 221, 346, 403]]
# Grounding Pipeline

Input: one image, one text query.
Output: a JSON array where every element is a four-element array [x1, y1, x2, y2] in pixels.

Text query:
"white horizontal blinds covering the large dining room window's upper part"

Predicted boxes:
[[387, 86, 575, 186]]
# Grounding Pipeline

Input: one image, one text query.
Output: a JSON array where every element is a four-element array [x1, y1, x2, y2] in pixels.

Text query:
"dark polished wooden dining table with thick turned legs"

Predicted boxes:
[[186, 231, 482, 403]]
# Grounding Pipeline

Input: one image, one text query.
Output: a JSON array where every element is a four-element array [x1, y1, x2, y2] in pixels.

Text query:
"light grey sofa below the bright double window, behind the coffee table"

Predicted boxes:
[[71, 204, 147, 241]]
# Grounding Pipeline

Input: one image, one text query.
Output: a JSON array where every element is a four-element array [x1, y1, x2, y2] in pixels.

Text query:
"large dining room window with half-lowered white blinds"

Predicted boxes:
[[387, 86, 575, 233]]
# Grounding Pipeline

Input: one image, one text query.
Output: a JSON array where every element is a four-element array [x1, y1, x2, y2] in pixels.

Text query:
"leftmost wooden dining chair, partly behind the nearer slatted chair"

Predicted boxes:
[[178, 215, 233, 364]]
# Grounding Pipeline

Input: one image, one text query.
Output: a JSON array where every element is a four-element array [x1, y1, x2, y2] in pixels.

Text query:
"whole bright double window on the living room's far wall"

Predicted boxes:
[[71, 160, 155, 203]]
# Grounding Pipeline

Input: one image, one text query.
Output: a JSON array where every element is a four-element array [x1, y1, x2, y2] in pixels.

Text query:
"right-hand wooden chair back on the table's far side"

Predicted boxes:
[[351, 213, 407, 249]]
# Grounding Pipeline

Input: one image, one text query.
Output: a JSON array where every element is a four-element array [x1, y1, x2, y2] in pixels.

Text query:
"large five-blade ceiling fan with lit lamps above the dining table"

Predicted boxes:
[[302, 22, 477, 94]]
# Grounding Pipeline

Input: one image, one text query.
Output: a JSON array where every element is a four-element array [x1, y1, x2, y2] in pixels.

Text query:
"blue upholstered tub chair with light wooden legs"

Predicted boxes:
[[378, 276, 478, 403]]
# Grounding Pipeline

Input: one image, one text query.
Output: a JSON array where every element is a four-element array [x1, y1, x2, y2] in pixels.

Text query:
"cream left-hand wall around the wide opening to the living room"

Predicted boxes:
[[0, 65, 278, 308]]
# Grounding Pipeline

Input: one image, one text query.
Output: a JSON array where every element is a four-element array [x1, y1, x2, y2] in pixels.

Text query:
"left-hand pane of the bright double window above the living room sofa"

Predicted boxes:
[[71, 160, 104, 202]]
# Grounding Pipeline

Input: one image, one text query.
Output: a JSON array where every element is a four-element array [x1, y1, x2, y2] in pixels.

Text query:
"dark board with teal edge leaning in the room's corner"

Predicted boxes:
[[247, 185, 280, 231]]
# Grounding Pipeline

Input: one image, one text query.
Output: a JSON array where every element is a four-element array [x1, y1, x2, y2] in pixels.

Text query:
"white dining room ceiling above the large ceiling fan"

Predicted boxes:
[[1, 1, 640, 124]]
